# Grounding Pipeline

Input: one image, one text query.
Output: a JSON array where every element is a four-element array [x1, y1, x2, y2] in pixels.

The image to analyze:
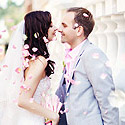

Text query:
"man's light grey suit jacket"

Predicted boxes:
[[56, 40, 119, 125]]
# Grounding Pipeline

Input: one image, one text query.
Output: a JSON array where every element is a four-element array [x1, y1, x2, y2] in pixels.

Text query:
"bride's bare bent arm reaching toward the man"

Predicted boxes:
[[18, 57, 59, 123]]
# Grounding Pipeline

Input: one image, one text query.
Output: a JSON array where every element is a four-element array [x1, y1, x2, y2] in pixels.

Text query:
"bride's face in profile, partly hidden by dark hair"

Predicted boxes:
[[48, 23, 57, 41]]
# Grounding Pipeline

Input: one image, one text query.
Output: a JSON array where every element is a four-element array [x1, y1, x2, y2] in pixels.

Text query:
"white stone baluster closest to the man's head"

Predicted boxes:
[[95, 18, 107, 53]]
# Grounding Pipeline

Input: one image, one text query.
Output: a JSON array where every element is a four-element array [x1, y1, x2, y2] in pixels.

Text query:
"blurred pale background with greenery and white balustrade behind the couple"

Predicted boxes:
[[0, 0, 125, 125]]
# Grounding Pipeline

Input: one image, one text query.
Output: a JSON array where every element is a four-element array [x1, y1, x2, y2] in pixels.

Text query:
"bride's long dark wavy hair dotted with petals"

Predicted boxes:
[[24, 11, 55, 76]]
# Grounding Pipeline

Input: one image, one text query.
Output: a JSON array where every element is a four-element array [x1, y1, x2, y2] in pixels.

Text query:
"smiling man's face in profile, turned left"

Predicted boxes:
[[59, 12, 77, 46]]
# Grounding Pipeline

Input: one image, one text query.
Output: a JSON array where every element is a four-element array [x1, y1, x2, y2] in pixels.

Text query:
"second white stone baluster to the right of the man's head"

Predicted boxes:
[[101, 16, 118, 68]]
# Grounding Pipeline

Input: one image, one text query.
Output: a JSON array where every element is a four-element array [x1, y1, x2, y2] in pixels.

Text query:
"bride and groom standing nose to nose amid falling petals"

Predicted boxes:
[[0, 7, 119, 125]]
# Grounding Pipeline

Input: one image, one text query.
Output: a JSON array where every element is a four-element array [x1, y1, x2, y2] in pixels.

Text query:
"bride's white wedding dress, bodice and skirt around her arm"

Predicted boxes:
[[0, 77, 50, 125]]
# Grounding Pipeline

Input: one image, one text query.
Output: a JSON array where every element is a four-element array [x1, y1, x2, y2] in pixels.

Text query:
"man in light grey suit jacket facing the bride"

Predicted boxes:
[[56, 7, 119, 125]]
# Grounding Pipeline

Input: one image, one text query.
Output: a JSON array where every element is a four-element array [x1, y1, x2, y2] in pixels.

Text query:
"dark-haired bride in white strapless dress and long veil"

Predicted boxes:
[[0, 11, 59, 125]]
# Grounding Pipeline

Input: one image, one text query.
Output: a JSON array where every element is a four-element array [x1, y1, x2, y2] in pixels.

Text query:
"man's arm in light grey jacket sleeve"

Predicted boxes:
[[84, 49, 119, 125]]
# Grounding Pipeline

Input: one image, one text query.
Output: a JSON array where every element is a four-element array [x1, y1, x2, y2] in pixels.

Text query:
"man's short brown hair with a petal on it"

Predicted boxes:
[[67, 7, 95, 37]]
